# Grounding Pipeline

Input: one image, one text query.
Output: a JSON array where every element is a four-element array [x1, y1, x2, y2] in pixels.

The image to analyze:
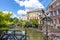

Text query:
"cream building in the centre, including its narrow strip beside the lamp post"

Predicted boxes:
[[27, 10, 41, 29]]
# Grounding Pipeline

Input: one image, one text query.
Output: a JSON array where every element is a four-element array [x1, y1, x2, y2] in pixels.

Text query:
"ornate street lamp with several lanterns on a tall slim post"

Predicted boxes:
[[41, 10, 52, 40]]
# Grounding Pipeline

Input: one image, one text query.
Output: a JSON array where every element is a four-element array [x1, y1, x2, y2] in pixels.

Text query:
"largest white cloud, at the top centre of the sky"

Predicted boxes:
[[15, 0, 44, 10]]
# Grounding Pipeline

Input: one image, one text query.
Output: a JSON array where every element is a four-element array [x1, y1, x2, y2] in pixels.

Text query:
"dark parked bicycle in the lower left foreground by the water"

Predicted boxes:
[[1, 29, 29, 40]]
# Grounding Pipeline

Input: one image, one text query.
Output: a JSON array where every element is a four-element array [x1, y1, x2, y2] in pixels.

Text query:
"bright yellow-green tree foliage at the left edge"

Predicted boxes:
[[0, 11, 12, 28]]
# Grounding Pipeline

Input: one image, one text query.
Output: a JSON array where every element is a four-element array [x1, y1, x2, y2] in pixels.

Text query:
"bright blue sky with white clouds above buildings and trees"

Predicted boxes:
[[0, 0, 51, 18]]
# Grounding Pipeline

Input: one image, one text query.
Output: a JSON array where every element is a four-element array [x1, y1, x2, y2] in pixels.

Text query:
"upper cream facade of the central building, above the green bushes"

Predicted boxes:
[[27, 11, 40, 21]]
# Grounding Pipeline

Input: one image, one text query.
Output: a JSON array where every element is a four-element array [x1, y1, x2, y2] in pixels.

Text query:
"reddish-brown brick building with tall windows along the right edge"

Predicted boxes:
[[46, 0, 60, 29]]
